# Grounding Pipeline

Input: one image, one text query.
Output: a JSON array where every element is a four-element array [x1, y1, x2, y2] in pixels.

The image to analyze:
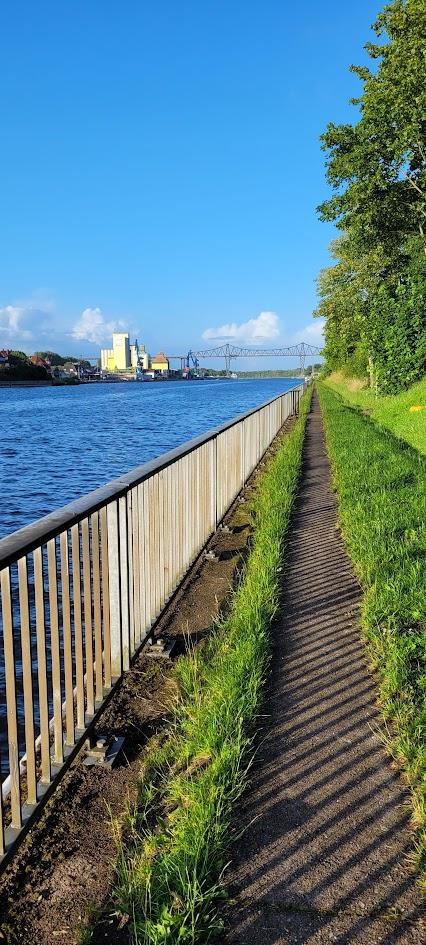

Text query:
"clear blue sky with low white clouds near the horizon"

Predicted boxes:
[[0, 0, 380, 367]]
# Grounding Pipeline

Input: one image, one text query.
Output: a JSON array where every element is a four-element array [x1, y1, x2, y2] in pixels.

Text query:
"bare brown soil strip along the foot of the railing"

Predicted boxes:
[[0, 420, 293, 945]]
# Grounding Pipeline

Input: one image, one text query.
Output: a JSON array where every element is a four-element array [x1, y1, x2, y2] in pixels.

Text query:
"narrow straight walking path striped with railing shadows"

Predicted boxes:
[[224, 396, 426, 945]]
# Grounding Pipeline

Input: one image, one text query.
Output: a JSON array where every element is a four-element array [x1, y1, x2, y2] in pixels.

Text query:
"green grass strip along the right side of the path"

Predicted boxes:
[[319, 384, 426, 875]]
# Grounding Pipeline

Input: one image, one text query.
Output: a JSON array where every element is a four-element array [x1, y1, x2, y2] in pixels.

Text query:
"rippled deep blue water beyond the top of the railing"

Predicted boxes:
[[0, 378, 298, 537]]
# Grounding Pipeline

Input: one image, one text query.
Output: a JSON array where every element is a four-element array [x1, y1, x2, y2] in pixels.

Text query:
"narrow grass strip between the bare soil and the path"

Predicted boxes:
[[110, 391, 311, 945]]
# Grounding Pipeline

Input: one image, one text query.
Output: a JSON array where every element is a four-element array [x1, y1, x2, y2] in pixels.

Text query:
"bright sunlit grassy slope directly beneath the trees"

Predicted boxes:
[[325, 373, 426, 453]]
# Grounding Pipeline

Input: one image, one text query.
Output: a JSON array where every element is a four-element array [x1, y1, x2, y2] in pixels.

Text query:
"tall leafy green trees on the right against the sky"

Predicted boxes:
[[315, 0, 426, 392]]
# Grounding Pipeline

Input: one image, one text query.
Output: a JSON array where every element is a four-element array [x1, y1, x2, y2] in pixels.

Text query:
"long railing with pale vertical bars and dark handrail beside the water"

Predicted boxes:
[[0, 385, 303, 863]]
